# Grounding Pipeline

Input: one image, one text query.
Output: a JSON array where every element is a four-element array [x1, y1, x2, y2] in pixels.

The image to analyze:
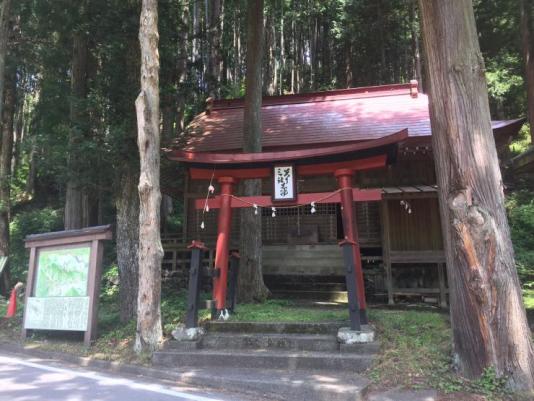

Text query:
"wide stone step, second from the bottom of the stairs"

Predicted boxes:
[[152, 350, 373, 373]]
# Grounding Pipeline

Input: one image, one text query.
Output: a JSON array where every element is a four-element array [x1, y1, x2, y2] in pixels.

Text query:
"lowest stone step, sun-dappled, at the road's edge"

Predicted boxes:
[[162, 367, 371, 401]]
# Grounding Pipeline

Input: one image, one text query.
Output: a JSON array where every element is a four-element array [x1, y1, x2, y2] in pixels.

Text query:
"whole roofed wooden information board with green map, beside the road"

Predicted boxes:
[[21, 225, 113, 346]]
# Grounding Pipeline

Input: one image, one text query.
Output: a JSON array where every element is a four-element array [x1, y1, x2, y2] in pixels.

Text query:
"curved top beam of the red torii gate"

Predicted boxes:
[[167, 129, 408, 167]]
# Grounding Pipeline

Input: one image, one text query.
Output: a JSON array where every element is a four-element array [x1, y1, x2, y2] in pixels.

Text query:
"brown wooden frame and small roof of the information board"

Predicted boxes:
[[22, 225, 113, 346]]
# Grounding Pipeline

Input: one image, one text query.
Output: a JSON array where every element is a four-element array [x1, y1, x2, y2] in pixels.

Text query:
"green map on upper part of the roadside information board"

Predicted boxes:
[[34, 246, 91, 298]]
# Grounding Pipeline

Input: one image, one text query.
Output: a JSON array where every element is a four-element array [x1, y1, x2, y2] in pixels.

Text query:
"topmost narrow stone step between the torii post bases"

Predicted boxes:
[[203, 321, 349, 335]]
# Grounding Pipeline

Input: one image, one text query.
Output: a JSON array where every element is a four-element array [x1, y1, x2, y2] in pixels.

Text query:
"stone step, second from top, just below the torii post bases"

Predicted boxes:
[[200, 333, 339, 352]]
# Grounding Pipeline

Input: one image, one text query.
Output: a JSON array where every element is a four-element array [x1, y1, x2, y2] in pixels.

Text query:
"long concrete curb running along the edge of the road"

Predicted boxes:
[[0, 343, 370, 401]]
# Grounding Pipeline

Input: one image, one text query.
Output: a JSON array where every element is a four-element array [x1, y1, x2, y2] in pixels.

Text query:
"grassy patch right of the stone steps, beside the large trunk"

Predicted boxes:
[[368, 309, 524, 401]]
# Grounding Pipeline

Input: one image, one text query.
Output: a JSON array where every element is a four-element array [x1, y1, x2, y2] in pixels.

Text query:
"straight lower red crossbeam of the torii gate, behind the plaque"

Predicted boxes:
[[195, 188, 382, 210]]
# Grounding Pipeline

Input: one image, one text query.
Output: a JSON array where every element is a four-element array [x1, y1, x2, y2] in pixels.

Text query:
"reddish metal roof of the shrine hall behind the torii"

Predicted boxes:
[[179, 81, 520, 152]]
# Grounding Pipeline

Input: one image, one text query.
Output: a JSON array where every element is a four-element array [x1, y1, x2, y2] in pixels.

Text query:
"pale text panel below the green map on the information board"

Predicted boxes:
[[24, 297, 89, 331]]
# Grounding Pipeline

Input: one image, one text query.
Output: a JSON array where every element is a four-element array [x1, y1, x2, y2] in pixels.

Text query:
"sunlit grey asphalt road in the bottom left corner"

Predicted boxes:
[[0, 354, 250, 401]]
